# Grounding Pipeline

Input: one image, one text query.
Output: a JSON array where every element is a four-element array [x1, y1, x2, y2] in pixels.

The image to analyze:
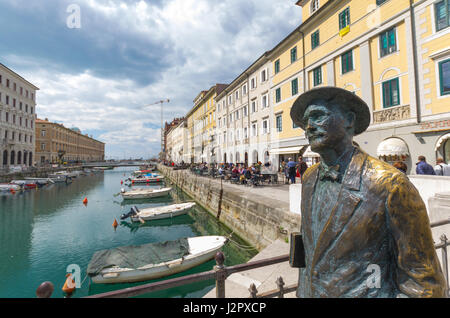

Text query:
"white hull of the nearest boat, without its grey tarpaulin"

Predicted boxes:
[[88, 236, 228, 284]]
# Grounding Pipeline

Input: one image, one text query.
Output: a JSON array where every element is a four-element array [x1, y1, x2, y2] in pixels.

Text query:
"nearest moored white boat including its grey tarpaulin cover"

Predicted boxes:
[[87, 236, 228, 284]]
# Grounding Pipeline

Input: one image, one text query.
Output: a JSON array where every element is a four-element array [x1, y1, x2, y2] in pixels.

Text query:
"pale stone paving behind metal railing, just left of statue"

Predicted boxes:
[[203, 240, 298, 298]]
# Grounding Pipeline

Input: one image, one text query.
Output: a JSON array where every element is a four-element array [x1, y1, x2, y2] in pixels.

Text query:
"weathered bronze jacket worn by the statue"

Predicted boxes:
[[297, 148, 446, 297]]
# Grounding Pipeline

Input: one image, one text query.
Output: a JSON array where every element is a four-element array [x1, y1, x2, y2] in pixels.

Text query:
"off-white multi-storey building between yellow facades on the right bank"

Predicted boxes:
[[216, 52, 273, 165]]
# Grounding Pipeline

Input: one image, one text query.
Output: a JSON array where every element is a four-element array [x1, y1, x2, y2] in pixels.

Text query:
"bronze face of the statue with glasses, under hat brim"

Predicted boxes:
[[303, 102, 352, 153]]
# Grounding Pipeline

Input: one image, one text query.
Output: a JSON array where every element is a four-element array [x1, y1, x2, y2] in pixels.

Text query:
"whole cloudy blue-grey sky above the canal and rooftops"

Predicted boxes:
[[0, 0, 301, 159]]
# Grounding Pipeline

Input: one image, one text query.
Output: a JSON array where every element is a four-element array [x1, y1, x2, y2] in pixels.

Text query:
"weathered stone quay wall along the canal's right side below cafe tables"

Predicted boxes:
[[158, 165, 300, 250]]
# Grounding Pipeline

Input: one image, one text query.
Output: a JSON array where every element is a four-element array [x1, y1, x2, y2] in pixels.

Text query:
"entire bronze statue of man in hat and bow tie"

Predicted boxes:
[[290, 87, 446, 297]]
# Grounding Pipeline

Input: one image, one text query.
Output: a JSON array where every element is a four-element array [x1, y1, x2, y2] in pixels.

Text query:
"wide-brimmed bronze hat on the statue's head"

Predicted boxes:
[[291, 86, 370, 135]]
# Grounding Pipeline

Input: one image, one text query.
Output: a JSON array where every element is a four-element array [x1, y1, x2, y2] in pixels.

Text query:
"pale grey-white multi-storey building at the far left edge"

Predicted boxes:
[[0, 63, 39, 169]]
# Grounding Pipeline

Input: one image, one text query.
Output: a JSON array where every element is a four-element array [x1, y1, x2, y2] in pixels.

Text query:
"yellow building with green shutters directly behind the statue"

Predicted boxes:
[[271, 0, 450, 172]]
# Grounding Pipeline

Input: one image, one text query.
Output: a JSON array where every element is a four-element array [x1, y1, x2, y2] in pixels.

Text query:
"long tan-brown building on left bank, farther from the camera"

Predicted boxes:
[[35, 118, 105, 165]]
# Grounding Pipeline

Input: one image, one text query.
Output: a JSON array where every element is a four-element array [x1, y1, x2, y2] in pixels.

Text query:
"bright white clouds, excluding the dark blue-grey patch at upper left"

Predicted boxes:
[[2, 0, 301, 157]]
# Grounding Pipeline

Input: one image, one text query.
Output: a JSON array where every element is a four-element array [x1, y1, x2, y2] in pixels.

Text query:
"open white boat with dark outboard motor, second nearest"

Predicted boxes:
[[120, 202, 195, 222]]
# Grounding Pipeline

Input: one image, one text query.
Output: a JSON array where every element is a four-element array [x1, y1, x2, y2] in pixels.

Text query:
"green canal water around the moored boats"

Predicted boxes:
[[0, 167, 256, 298]]
